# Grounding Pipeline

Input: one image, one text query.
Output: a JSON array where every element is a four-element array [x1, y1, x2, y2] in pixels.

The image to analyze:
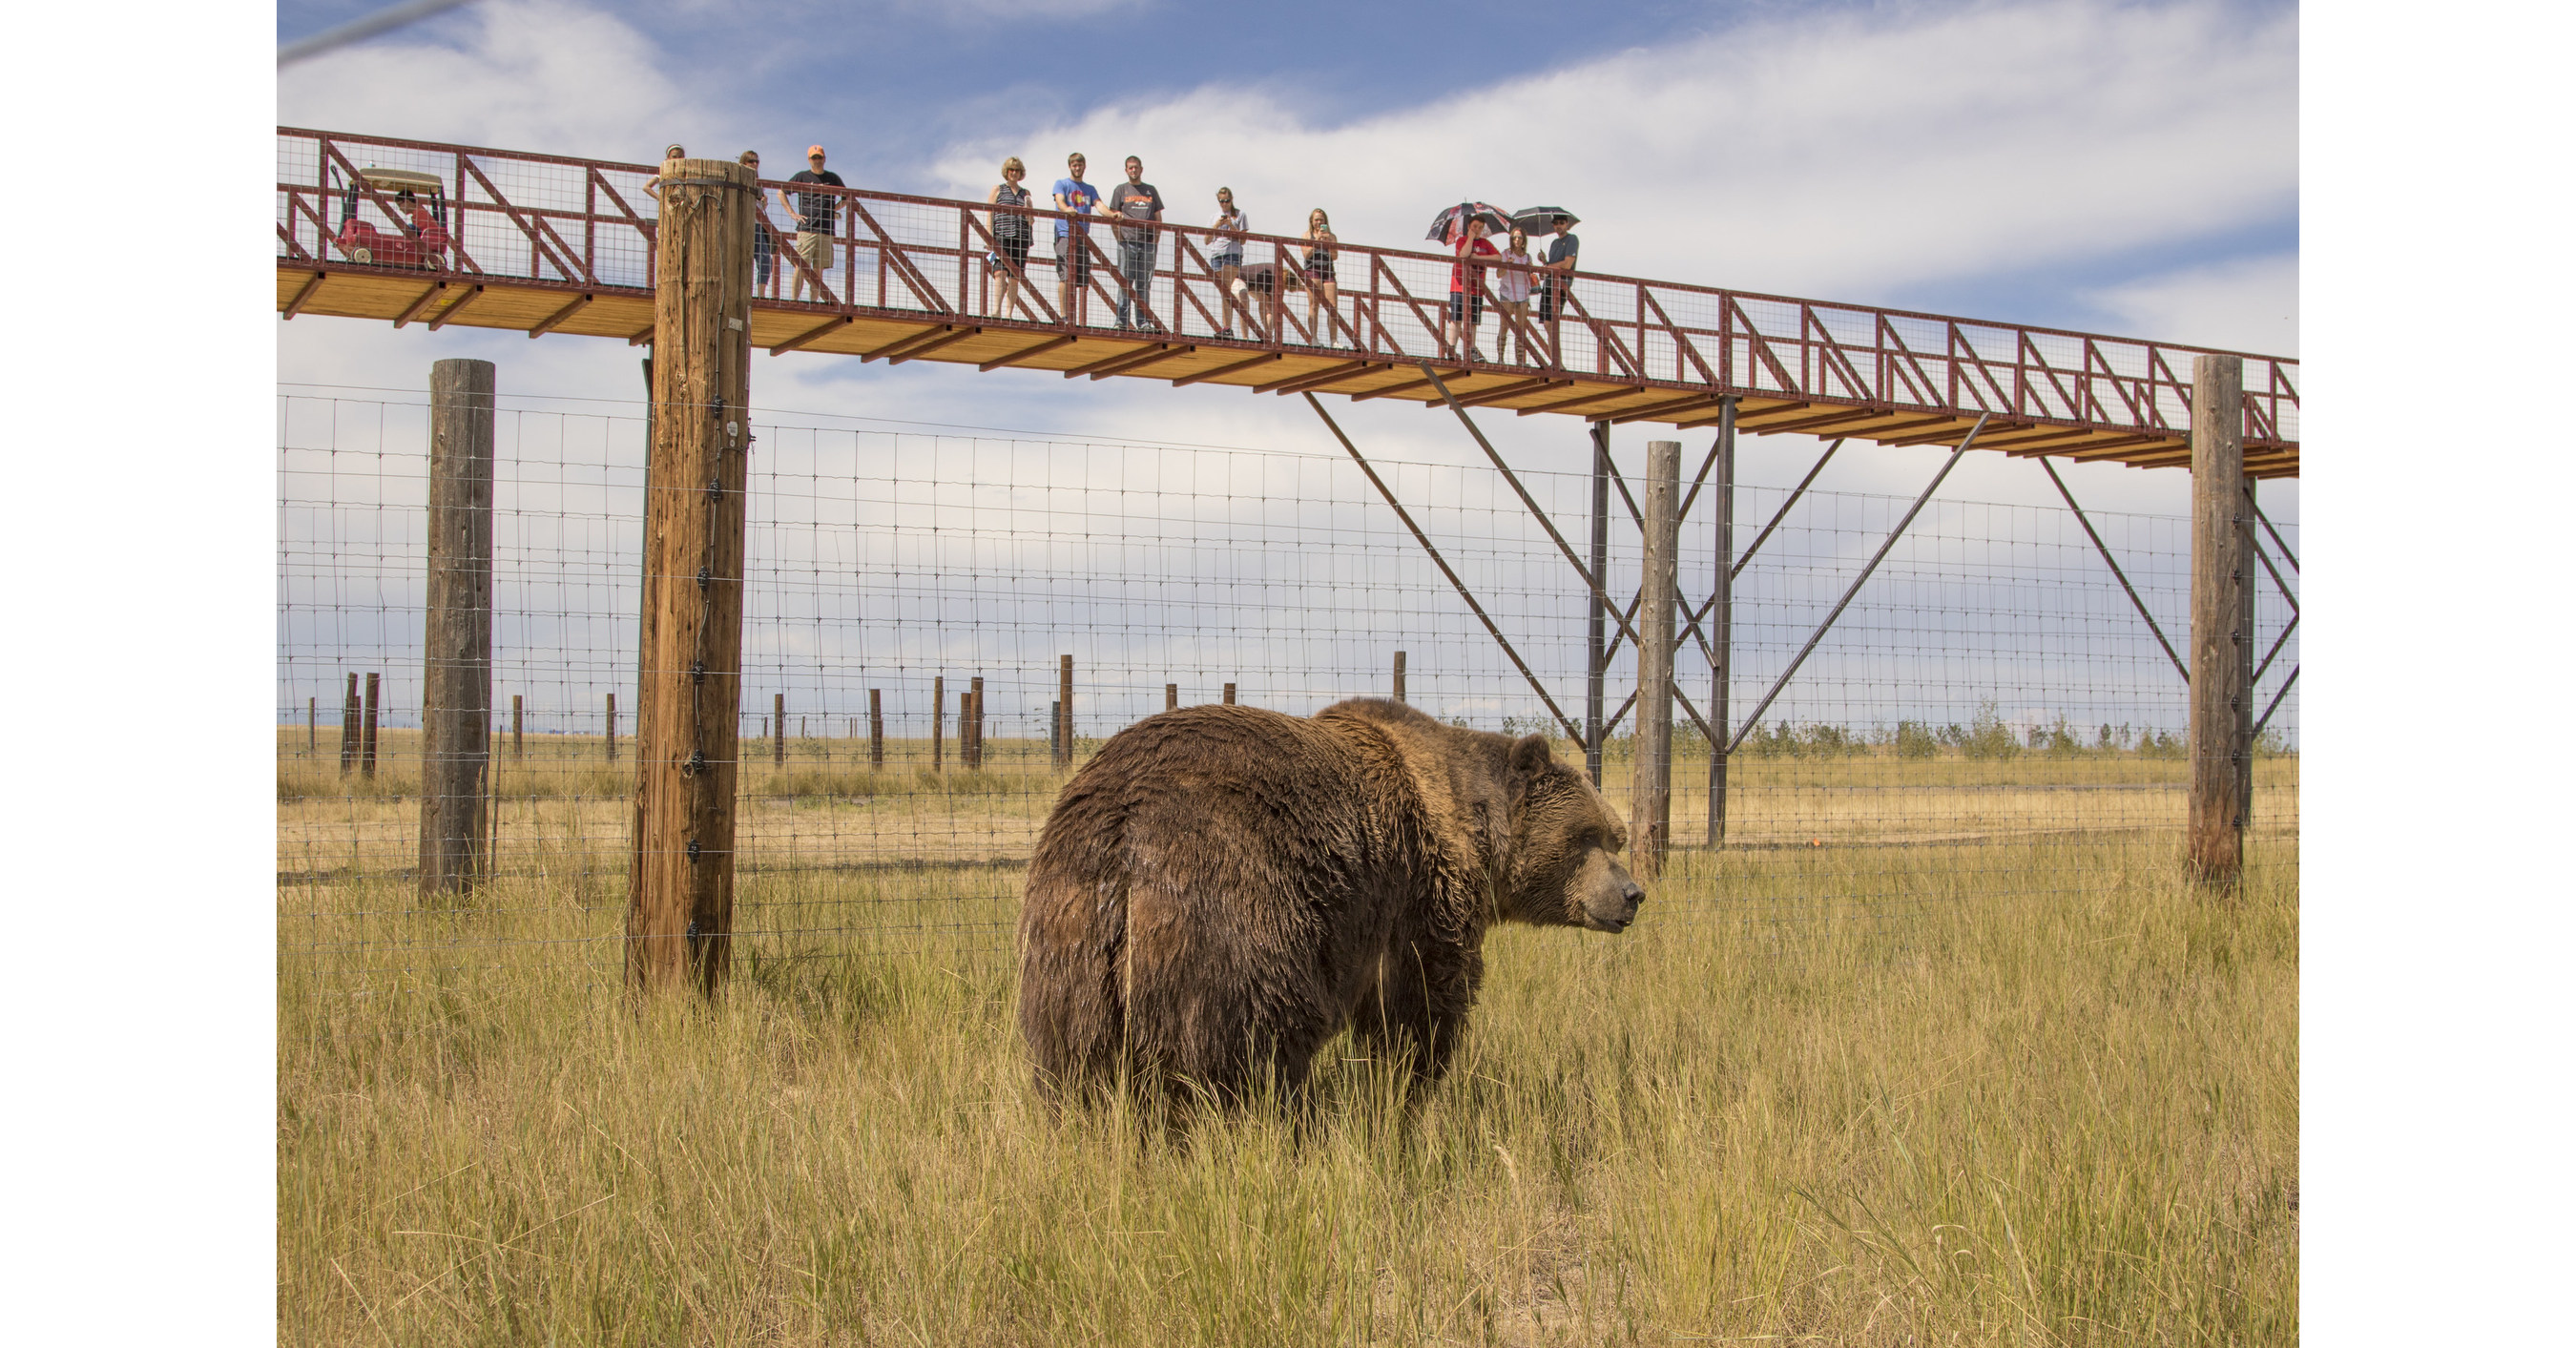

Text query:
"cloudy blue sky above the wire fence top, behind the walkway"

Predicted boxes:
[[279, 0, 2297, 515]]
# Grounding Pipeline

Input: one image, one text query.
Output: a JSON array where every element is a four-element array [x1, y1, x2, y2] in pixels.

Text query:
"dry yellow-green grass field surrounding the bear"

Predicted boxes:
[[279, 730, 2297, 1345]]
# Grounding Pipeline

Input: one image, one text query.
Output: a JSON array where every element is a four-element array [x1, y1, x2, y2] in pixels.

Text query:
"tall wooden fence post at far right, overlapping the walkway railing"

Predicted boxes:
[[2190, 356, 2254, 881]]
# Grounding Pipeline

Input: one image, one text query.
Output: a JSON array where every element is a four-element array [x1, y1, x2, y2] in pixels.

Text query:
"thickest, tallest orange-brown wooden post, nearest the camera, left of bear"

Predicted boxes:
[[626, 160, 755, 992]]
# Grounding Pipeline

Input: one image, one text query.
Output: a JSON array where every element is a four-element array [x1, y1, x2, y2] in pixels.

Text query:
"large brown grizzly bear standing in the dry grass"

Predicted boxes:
[[1020, 698, 1646, 1103]]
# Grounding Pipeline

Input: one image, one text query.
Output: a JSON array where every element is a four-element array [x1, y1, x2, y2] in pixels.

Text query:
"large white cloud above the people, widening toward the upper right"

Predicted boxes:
[[935, 0, 2297, 297]]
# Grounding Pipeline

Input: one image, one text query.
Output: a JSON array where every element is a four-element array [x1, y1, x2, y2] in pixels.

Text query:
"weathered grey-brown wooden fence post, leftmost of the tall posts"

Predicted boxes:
[[420, 361, 494, 897]]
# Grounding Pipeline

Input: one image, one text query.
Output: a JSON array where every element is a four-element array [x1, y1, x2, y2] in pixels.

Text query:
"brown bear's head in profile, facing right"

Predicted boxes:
[[1497, 735, 1646, 930]]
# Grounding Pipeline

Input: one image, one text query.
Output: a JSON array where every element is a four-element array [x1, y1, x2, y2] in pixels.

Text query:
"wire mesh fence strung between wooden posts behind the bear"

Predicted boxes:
[[276, 392, 2297, 995]]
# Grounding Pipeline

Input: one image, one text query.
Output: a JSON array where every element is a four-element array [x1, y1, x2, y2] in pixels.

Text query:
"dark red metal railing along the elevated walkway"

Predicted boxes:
[[279, 126, 2297, 448]]
